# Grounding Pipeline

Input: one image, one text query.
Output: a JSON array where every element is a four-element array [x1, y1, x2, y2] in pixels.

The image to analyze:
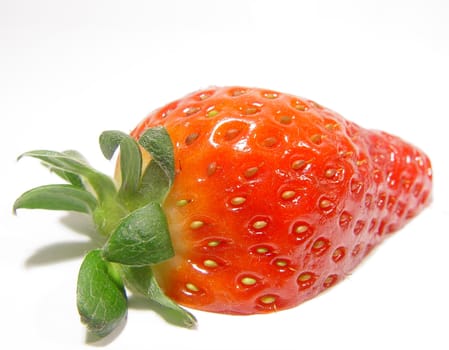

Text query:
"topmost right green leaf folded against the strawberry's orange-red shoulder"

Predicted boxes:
[[139, 127, 175, 187]]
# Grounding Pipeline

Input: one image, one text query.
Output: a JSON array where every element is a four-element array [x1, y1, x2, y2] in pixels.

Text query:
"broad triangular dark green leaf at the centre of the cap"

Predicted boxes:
[[103, 203, 174, 266]]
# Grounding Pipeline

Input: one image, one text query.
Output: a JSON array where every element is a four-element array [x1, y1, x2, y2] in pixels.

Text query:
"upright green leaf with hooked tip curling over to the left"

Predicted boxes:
[[100, 130, 142, 195]]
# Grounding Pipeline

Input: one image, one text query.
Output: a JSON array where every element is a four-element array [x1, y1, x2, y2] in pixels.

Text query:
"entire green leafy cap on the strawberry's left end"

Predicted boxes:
[[13, 127, 196, 337]]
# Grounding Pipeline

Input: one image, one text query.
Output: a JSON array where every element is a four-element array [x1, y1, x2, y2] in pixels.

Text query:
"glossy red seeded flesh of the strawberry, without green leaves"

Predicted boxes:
[[132, 87, 432, 314]]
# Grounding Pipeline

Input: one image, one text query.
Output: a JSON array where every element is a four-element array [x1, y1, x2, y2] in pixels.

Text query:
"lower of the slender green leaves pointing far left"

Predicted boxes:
[[14, 184, 97, 214]]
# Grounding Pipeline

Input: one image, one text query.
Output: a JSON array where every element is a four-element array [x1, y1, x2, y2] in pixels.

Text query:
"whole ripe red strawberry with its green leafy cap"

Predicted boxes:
[[15, 87, 432, 335]]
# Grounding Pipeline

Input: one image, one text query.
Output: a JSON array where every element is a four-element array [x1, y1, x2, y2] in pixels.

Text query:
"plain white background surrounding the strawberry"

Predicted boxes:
[[0, 0, 449, 350]]
